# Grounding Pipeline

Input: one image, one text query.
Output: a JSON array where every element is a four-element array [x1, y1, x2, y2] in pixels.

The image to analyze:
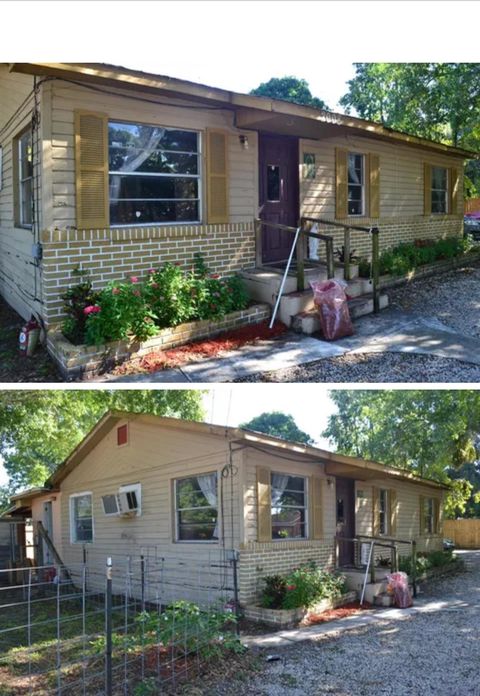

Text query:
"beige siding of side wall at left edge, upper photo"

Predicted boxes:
[[0, 65, 40, 317]]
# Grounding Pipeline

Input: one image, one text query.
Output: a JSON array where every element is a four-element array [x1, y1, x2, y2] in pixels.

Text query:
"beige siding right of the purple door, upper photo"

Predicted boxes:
[[300, 136, 463, 224]]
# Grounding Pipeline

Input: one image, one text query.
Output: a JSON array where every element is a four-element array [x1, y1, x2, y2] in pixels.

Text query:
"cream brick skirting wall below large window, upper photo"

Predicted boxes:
[[42, 221, 255, 327]]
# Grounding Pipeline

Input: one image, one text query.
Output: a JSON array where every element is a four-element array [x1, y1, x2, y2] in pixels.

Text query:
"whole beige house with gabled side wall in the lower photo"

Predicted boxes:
[[8, 412, 445, 604]]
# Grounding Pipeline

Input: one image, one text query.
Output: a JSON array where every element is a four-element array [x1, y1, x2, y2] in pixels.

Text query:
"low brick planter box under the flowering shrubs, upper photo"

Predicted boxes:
[[47, 304, 271, 380]]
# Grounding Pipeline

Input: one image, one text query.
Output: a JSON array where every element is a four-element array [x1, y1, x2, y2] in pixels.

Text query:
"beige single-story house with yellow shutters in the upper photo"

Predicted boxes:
[[0, 63, 475, 327]]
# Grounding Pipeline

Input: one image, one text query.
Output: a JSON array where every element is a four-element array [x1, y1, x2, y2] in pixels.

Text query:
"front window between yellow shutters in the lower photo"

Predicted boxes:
[[271, 472, 307, 539]]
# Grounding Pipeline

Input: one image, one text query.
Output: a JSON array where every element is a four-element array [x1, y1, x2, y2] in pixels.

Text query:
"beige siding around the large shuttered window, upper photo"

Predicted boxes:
[[44, 82, 258, 227]]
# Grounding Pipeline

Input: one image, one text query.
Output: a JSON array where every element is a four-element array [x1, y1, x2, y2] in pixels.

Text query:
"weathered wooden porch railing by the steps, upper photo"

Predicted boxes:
[[254, 216, 380, 313]]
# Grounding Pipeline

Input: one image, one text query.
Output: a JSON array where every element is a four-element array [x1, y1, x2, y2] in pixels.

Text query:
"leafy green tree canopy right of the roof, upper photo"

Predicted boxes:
[[340, 63, 480, 195]]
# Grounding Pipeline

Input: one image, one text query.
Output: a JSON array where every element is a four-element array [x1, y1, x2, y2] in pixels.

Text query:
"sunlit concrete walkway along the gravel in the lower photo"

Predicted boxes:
[[242, 551, 480, 648]]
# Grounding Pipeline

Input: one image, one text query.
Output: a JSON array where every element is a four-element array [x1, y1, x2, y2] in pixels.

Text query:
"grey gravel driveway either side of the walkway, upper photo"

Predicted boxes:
[[238, 262, 480, 382]]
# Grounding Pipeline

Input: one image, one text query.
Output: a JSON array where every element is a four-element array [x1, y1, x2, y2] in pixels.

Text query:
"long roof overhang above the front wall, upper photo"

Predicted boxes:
[[9, 63, 480, 159]]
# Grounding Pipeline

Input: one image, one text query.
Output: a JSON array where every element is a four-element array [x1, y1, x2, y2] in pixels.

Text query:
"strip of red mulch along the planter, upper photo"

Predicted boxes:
[[114, 321, 288, 375]]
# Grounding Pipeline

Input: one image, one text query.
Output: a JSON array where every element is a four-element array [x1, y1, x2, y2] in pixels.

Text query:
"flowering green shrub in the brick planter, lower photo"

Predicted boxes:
[[260, 562, 345, 609]]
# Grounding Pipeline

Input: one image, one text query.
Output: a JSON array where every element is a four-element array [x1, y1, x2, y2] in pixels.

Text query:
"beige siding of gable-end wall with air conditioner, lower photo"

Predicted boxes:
[[61, 420, 240, 564]]
